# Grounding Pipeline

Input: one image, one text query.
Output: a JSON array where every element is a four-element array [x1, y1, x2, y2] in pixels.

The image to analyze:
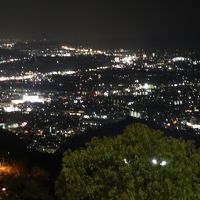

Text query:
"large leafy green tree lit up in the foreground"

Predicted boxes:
[[55, 124, 200, 200]]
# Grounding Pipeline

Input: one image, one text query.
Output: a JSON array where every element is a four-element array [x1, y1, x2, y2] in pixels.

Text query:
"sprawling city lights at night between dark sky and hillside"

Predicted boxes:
[[0, 41, 200, 153]]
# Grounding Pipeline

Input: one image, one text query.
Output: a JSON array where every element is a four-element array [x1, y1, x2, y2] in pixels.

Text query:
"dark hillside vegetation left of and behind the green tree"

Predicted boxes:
[[0, 118, 200, 200]]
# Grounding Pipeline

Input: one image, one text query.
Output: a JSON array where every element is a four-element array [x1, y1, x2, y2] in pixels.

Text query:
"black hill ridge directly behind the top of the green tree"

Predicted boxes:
[[57, 118, 200, 156]]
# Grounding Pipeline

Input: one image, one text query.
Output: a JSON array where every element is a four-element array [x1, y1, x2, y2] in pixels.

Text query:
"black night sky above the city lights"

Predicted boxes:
[[0, 0, 200, 48]]
